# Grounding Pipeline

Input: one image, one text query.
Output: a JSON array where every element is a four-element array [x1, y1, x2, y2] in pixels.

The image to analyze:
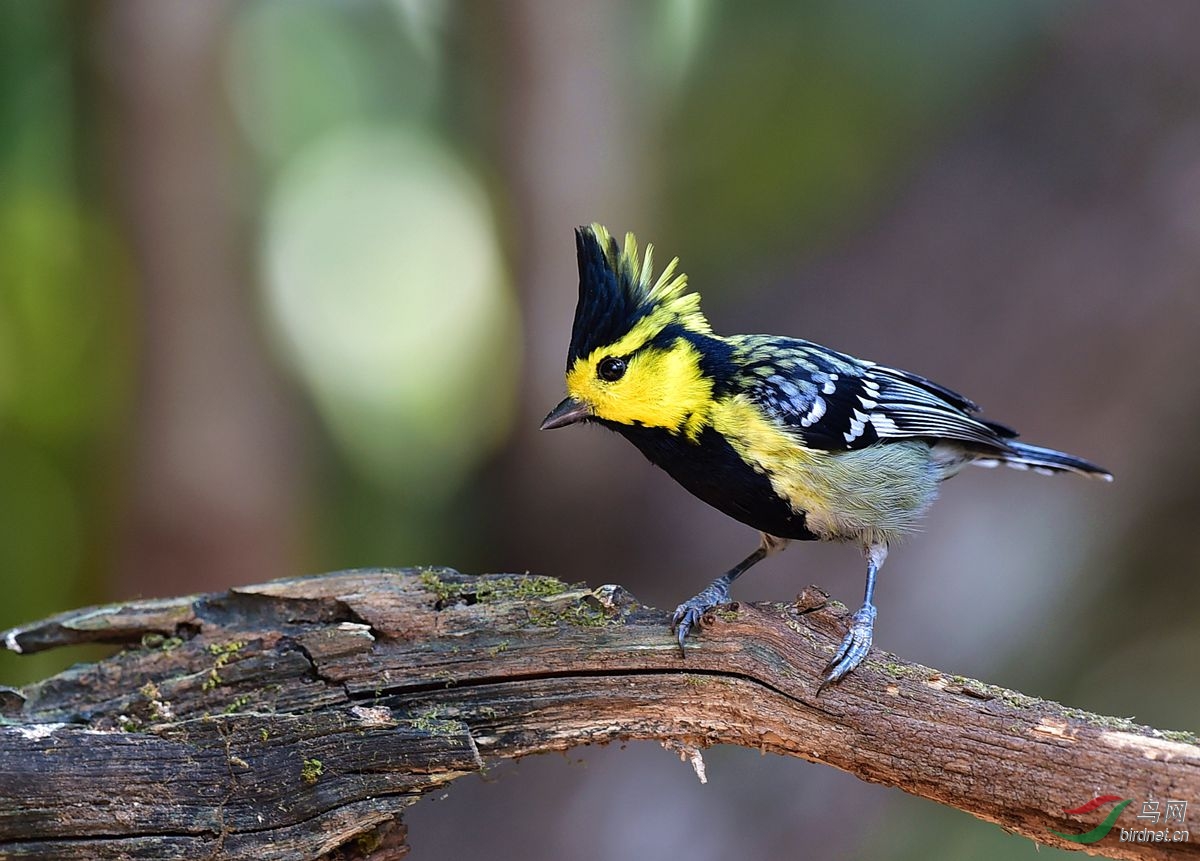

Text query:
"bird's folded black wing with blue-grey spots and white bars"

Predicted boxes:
[[736, 336, 1016, 451]]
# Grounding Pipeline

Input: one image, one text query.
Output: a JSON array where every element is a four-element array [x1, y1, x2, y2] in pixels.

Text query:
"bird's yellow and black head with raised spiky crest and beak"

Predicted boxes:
[[541, 224, 713, 436]]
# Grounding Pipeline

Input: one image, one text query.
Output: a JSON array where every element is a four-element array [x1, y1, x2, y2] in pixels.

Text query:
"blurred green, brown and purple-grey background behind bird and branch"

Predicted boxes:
[[0, 0, 1200, 860]]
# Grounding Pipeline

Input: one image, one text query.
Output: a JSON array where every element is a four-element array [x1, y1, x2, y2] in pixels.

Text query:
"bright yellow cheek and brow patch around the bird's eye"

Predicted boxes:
[[566, 319, 713, 439]]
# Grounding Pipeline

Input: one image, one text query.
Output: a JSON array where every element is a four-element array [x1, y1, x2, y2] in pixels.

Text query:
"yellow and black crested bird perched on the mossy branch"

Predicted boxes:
[[541, 224, 1112, 687]]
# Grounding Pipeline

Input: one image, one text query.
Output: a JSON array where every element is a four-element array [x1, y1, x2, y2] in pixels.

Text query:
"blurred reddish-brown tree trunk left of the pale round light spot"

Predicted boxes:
[[97, 0, 296, 604]]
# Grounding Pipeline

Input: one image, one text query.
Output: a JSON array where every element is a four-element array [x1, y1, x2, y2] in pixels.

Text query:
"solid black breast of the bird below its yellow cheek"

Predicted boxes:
[[601, 422, 817, 541]]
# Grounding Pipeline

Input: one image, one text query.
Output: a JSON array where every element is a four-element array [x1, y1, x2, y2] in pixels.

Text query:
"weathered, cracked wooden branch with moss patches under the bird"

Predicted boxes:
[[0, 570, 1200, 860]]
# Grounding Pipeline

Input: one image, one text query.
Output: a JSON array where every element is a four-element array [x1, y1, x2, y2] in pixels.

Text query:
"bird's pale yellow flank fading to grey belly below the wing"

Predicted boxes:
[[712, 395, 938, 543]]
